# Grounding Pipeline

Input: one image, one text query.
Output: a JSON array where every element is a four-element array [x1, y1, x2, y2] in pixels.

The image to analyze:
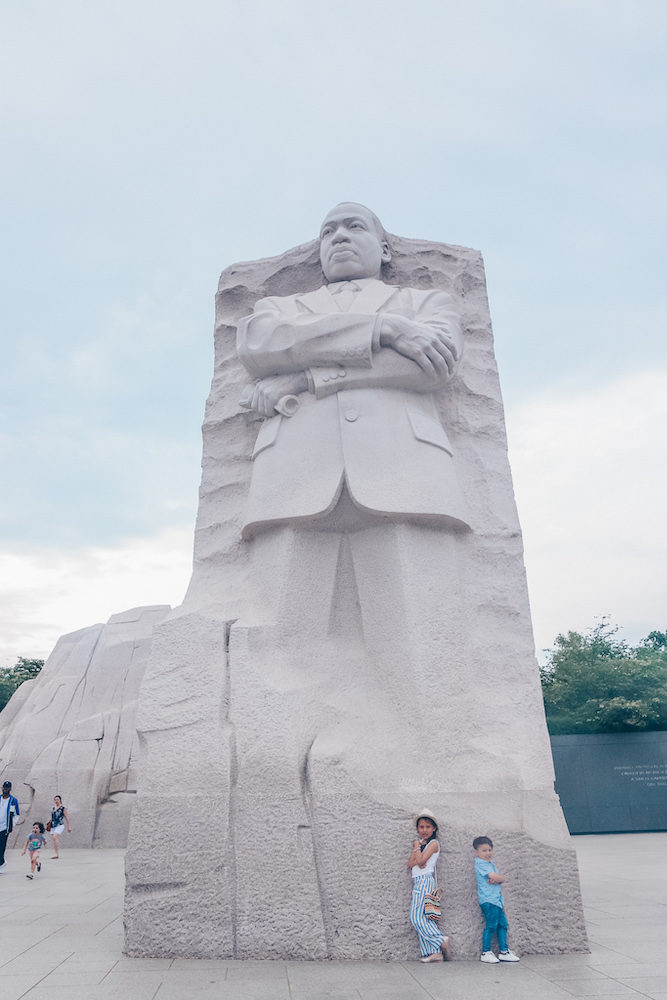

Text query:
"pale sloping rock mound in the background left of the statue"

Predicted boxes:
[[0, 605, 170, 847]]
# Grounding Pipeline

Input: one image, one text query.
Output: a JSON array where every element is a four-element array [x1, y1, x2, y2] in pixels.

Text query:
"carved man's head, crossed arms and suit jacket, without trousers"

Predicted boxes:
[[237, 203, 466, 537]]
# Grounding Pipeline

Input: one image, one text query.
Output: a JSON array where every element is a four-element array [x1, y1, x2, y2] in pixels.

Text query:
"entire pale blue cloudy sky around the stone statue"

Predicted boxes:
[[0, 0, 667, 665]]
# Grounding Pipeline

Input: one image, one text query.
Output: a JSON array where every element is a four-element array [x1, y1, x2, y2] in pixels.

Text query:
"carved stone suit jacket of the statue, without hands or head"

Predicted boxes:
[[237, 278, 466, 538]]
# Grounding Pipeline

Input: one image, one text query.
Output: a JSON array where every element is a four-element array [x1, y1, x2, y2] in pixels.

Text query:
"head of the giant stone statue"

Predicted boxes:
[[320, 201, 391, 281]]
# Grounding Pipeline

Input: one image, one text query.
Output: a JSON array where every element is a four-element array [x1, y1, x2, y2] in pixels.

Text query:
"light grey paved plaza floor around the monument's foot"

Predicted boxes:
[[0, 833, 667, 1000]]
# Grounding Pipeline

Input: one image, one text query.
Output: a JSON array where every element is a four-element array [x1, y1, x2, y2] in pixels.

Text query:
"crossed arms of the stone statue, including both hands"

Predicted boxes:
[[237, 292, 462, 417]]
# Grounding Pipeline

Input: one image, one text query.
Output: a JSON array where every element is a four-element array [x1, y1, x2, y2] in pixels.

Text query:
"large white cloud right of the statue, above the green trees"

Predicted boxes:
[[507, 370, 667, 650]]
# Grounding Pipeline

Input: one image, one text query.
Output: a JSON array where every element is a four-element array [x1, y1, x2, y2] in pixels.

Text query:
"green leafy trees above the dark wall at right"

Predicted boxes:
[[540, 619, 667, 734]]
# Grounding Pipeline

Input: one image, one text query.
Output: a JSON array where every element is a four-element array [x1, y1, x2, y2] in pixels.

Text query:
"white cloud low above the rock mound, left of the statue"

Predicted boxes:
[[0, 527, 193, 666]]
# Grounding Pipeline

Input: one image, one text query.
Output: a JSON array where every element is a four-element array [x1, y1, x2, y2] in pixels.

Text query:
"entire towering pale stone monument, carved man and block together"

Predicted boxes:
[[126, 197, 585, 960]]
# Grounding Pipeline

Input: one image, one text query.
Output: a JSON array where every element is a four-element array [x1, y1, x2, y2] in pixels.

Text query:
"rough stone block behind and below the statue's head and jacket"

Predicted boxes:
[[125, 237, 586, 959]]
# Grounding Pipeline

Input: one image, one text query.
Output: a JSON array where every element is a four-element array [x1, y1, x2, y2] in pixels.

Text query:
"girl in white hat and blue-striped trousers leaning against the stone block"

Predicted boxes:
[[408, 809, 450, 962]]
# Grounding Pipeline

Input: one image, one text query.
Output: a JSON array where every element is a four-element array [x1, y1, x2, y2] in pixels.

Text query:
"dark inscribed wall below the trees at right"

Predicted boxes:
[[551, 732, 667, 833]]
